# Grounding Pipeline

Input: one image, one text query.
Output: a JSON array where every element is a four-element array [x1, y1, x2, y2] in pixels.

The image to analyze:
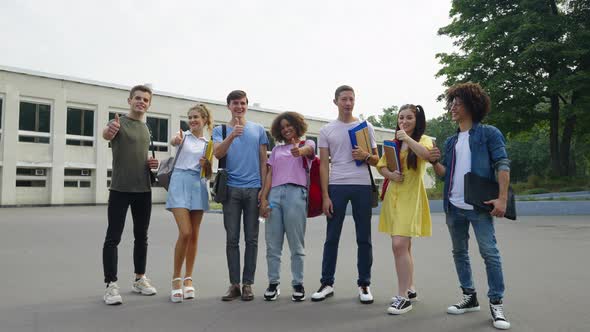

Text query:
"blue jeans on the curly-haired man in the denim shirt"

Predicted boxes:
[[447, 204, 504, 301]]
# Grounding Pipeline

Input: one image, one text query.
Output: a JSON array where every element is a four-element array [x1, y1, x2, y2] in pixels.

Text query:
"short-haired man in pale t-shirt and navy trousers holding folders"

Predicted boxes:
[[311, 85, 379, 304]]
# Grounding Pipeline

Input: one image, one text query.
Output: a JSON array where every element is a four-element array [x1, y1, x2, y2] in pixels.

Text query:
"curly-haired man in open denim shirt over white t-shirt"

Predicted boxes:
[[429, 82, 510, 330]]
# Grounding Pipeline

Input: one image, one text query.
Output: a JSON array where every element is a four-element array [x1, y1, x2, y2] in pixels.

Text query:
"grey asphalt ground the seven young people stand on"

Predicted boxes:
[[0, 205, 590, 332]]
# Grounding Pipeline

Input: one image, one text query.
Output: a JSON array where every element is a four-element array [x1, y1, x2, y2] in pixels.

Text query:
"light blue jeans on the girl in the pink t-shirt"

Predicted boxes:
[[264, 184, 307, 286]]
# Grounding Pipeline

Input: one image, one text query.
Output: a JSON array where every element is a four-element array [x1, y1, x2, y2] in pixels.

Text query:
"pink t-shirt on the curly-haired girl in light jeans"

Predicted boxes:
[[267, 140, 315, 187]]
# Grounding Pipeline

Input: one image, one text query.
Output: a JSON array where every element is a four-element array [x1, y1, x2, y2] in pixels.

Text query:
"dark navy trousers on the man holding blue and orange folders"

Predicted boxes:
[[321, 185, 373, 286]]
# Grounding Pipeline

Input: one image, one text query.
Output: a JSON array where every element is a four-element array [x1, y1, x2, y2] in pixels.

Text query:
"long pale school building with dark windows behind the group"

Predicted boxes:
[[0, 66, 429, 206]]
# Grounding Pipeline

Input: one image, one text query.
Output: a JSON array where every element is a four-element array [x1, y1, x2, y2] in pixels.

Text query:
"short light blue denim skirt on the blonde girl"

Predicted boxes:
[[166, 168, 209, 211]]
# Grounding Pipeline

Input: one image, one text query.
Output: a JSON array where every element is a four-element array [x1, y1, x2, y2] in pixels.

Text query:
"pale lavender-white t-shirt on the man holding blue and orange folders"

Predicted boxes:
[[318, 120, 377, 185]]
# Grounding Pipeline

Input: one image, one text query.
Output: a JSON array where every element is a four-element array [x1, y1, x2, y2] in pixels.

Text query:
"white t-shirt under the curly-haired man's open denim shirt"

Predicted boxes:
[[449, 131, 473, 210]]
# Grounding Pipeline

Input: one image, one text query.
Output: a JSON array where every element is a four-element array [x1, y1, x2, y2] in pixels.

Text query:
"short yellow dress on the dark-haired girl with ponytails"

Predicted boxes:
[[377, 135, 433, 237]]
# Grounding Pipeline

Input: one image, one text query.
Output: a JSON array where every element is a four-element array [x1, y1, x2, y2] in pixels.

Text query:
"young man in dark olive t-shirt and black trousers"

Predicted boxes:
[[102, 85, 158, 305]]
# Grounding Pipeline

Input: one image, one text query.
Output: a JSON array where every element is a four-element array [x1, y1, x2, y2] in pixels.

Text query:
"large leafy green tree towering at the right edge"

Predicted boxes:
[[437, 0, 590, 175]]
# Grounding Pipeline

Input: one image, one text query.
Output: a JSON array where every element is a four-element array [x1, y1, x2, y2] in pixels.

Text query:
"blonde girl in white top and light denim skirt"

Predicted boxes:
[[166, 104, 213, 302]]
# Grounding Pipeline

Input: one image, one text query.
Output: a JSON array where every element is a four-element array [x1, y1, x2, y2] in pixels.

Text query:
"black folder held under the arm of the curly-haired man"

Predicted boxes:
[[464, 172, 516, 220]]
